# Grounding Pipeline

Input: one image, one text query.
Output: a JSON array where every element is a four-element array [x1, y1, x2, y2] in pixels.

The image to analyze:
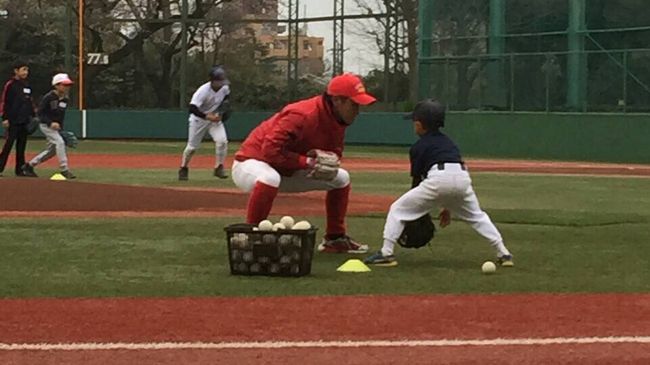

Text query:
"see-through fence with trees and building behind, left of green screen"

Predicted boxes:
[[0, 0, 416, 110]]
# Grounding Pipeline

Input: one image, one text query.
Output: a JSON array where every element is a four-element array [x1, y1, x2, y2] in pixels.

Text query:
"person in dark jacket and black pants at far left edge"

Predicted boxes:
[[0, 62, 34, 176]]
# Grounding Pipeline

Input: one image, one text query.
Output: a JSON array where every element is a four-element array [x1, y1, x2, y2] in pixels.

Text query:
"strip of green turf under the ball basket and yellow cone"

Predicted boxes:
[[0, 218, 650, 297]]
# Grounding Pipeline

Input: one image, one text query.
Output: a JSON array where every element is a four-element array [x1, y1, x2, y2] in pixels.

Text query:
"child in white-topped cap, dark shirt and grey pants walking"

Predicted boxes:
[[23, 73, 76, 179]]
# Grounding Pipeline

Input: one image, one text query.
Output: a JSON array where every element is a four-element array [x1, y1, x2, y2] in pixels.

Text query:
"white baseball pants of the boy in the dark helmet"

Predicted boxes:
[[381, 163, 510, 257]]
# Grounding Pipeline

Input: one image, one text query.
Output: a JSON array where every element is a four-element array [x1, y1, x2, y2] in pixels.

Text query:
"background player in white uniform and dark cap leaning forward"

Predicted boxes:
[[178, 66, 230, 181]]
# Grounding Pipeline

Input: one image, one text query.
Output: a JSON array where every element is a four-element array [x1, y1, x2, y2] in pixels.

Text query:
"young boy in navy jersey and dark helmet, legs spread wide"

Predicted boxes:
[[364, 99, 514, 267]]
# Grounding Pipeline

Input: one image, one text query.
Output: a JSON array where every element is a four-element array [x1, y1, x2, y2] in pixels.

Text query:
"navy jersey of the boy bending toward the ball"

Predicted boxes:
[[410, 130, 463, 179]]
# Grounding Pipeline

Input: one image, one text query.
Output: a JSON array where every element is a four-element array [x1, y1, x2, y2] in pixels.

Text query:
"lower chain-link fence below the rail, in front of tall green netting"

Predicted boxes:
[[418, 49, 650, 112]]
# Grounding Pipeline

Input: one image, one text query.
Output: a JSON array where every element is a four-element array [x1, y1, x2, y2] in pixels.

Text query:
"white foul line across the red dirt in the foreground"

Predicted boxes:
[[0, 336, 650, 351]]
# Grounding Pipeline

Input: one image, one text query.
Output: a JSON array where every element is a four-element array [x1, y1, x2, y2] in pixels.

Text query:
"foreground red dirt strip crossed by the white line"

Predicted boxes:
[[0, 294, 650, 364]]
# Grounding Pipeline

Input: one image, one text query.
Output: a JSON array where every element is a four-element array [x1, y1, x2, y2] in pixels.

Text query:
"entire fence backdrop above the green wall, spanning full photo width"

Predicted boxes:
[[0, 0, 650, 112]]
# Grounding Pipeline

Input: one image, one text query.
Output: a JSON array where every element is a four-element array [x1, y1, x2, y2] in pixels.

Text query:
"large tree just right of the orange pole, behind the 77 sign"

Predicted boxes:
[[77, 0, 236, 108]]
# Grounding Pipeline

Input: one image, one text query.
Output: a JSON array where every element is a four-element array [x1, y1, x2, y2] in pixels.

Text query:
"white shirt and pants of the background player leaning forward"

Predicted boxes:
[[181, 82, 230, 167]]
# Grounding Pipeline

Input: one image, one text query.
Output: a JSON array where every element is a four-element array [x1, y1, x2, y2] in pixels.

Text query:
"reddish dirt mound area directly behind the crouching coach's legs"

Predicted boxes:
[[0, 178, 392, 217]]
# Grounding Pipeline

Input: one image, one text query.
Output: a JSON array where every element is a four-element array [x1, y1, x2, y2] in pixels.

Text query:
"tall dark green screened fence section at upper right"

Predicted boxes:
[[419, 0, 650, 112]]
